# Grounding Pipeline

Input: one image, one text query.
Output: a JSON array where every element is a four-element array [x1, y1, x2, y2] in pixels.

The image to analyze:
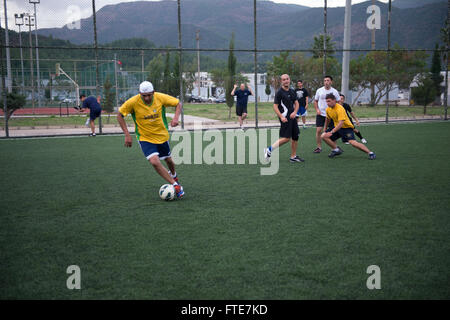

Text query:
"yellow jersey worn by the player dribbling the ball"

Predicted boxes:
[[119, 92, 180, 144]]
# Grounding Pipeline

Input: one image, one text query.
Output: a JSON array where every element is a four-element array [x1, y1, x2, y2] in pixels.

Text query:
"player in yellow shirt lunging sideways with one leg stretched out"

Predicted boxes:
[[322, 93, 376, 160]]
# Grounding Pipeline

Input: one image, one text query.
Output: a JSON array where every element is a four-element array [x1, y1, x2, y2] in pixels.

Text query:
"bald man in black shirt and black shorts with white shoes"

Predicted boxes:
[[264, 74, 305, 162]]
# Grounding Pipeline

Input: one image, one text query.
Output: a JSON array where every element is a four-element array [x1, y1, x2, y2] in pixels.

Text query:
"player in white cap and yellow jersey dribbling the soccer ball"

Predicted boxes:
[[117, 81, 184, 198]]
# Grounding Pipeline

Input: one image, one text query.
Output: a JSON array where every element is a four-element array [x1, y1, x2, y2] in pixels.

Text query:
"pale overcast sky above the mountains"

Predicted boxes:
[[0, 0, 388, 31]]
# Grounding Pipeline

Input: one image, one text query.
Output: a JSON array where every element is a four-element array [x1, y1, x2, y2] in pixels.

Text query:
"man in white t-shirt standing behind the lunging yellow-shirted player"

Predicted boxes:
[[314, 76, 340, 153]]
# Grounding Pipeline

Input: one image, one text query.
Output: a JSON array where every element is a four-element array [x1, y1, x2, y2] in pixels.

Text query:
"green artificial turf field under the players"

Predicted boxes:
[[0, 122, 450, 300]]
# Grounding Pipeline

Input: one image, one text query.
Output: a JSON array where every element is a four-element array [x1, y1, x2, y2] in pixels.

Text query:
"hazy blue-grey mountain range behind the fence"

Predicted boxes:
[[39, 0, 447, 50]]
